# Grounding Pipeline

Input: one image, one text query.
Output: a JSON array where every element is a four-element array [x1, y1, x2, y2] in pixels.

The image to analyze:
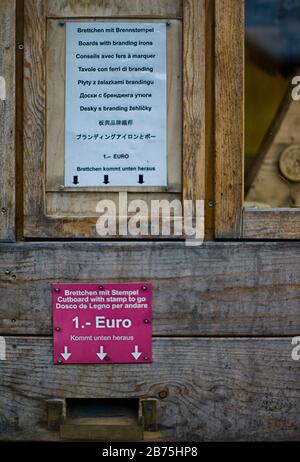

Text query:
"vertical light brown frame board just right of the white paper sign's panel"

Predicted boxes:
[[183, 0, 206, 200]]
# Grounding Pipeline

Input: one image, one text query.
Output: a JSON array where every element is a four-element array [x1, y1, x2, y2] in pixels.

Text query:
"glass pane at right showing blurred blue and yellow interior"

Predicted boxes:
[[245, 0, 300, 207]]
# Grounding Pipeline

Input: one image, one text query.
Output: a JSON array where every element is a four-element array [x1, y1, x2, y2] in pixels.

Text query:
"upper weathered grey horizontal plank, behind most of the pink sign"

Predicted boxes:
[[0, 242, 300, 336]]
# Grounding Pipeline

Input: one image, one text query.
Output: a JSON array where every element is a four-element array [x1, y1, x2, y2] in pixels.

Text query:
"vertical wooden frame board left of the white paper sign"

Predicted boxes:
[[24, 0, 46, 229]]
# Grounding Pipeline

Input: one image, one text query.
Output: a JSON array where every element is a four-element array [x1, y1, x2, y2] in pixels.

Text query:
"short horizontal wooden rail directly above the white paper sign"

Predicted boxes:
[[46, 0, 182, 18]]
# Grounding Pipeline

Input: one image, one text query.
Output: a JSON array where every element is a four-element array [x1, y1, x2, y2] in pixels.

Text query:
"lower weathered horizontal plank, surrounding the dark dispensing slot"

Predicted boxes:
[[0, 337, 300, 441]]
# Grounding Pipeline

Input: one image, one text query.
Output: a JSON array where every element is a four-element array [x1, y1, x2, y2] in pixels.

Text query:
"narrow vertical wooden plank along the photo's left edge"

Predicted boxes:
[[0, 0, 16, 242]]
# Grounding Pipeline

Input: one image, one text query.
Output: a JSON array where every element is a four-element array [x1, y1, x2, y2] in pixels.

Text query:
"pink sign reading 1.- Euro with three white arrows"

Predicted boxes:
[[52, 282, 152, 364]]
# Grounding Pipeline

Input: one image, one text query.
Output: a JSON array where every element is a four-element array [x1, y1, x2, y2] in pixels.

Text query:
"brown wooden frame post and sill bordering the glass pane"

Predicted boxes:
[[215, 0, 300, 239]]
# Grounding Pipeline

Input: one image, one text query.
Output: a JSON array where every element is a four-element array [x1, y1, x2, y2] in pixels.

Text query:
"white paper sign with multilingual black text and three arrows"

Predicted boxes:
[[65, 22, 167, 187]]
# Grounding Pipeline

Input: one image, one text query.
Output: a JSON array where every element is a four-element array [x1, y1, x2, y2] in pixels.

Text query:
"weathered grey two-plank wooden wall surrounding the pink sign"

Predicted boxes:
[[0, 242, 300, 441]]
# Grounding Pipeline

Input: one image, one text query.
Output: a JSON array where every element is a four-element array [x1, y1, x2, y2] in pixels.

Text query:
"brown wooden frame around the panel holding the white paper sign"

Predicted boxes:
[[23, 0, 207, 239]]
